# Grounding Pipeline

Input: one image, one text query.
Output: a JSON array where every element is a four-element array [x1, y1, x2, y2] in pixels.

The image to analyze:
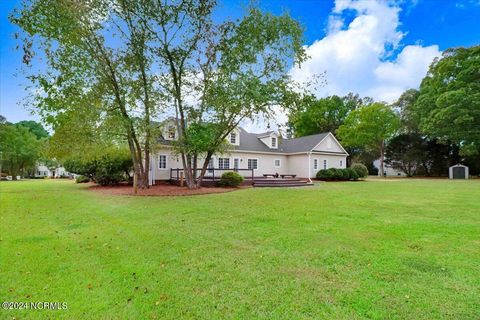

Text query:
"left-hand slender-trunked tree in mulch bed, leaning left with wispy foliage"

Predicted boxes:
[[11, 0, 159, 192]]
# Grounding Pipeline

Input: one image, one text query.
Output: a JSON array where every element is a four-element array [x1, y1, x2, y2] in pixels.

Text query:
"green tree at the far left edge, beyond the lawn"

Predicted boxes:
[[0, 123, 44, 179]]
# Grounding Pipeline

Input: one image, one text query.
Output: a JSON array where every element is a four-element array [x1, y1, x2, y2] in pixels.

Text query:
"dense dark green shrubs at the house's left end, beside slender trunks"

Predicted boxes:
[[64, 149, 133, 185]]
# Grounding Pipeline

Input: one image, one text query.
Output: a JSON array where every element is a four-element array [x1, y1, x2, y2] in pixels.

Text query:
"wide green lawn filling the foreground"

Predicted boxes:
[[0, 179, 480, 319]]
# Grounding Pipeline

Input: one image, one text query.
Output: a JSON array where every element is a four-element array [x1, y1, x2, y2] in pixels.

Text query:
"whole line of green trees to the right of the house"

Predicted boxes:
[[289, 46, 480, 176]]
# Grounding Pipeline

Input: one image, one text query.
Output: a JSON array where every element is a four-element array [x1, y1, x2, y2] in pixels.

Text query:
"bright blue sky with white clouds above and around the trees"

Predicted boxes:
[[0, 0, 480, 122]]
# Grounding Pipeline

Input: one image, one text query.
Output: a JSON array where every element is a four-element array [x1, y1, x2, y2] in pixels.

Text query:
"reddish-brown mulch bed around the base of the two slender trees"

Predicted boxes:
[[88, 184, 246, 196]]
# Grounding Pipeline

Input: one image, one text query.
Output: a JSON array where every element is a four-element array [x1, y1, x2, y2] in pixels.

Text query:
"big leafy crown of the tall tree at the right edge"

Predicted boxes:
[[414, 46, 480, 150]]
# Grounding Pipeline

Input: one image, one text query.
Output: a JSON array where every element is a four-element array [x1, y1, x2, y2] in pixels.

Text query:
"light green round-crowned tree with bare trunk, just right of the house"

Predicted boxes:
[[337, 102, 400, 176]]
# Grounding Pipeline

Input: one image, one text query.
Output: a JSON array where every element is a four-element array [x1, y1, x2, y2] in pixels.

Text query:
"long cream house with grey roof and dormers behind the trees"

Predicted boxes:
[[150, 124, 348, 183]]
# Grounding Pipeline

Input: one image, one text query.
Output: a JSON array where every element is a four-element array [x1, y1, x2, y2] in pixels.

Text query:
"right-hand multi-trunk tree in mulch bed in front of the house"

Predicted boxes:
[[148, 1, 304, 188]]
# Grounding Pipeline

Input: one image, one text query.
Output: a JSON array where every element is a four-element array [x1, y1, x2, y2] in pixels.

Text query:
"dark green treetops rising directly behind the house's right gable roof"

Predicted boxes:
[[289, 93, 370, 137]]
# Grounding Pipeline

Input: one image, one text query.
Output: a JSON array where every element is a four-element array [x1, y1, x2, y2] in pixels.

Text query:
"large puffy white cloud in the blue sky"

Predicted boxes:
[[291, 0, 440, 102]]
